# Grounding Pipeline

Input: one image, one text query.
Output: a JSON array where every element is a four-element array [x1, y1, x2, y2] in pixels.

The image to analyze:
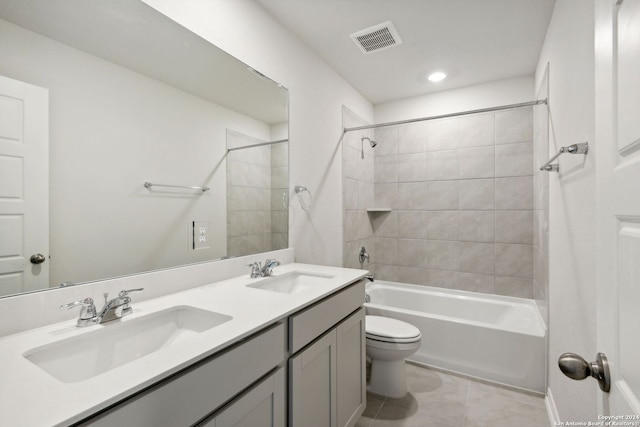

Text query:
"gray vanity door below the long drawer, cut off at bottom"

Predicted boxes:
[[198, 368, 286, 427]]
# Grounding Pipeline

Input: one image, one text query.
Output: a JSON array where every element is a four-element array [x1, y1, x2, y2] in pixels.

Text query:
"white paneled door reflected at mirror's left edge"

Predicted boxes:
[[0, 76, 49, 296]]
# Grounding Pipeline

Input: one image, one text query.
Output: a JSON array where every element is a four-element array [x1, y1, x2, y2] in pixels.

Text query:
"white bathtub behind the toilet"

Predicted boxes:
[[365, 280, 546, 393]]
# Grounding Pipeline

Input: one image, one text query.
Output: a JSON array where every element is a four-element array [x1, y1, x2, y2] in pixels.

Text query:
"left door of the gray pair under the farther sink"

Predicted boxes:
[[289, 329, 338, 427]]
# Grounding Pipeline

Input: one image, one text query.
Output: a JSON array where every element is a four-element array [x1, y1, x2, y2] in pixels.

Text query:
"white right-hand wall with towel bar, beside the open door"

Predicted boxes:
[[536, 0, 598, 421]]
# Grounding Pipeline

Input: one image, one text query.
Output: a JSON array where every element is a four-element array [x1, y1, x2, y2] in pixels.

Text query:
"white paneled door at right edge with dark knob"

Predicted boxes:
[[595, 0, 640, 418]]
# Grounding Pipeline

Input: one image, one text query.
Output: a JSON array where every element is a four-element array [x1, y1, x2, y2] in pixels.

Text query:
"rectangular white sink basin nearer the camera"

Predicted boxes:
[[24, 306, 232, 383]]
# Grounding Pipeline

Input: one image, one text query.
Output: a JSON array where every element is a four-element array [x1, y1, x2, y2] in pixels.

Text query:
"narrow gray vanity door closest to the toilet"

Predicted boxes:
[[336, 308, 367, 427]]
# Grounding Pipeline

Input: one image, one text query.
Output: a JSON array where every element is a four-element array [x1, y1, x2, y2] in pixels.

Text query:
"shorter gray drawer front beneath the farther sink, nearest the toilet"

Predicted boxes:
[[289, 280, 365, 354]]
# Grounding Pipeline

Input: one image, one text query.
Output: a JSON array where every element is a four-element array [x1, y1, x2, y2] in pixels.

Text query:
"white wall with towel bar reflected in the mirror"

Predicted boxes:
[[0, 21, 271, 285]]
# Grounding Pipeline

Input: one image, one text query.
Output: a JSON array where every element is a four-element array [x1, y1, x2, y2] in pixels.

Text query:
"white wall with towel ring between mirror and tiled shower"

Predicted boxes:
[[144, 0, 373, 266]]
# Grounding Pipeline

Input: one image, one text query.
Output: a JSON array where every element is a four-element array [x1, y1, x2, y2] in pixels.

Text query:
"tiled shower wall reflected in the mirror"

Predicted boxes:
[[227, 131, 289, 256]]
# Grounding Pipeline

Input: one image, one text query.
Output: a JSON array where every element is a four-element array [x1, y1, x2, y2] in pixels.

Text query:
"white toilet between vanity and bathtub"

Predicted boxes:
[[366, 315, 422, 398]]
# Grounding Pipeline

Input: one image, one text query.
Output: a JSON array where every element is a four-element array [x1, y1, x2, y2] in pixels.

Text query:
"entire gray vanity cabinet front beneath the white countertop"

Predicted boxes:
[[78, 282, 366, 427]]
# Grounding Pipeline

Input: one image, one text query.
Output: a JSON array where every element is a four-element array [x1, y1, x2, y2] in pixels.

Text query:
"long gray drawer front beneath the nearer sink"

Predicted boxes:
[[81, 323, 285, 427]]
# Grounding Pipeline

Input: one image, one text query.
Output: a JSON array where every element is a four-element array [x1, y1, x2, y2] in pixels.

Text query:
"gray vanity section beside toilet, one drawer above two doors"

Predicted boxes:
[[289, 283, 366, 427]]
